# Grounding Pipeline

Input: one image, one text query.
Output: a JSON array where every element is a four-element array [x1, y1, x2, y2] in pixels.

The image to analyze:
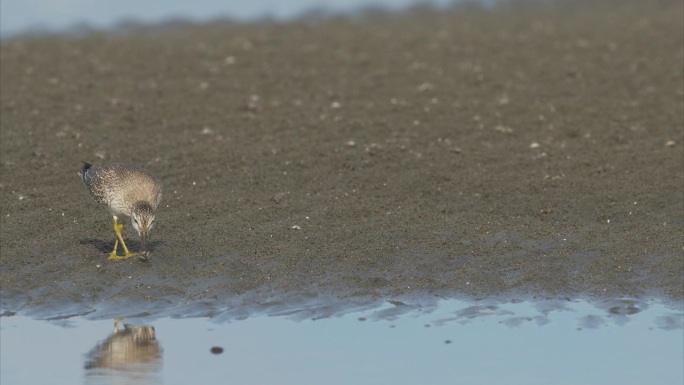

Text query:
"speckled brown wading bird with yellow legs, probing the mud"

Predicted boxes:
[[78, 162, 163, 261]]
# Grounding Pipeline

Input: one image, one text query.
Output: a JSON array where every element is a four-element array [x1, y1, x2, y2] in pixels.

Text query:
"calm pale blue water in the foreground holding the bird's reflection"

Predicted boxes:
[[0, 300, 684, 384]]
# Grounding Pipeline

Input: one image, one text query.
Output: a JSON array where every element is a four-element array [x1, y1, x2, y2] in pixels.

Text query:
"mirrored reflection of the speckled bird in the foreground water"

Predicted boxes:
[[85, 318, 162, 384]]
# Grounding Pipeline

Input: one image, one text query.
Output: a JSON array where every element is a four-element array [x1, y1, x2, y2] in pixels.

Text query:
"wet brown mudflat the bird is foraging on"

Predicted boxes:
[[0, 1, 684, 317]]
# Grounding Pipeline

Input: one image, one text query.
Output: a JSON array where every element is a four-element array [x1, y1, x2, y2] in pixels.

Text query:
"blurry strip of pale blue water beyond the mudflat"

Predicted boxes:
[[0, 0, 468, 37]]
